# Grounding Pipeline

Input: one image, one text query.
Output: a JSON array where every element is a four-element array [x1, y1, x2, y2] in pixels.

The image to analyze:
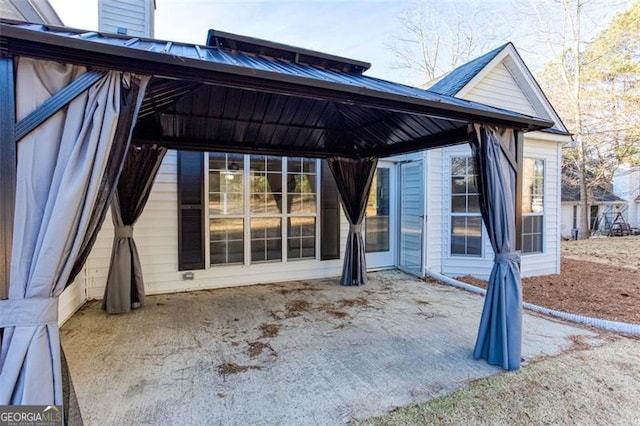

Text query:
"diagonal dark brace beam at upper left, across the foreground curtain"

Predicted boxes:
[[15, 71, 105, 142]]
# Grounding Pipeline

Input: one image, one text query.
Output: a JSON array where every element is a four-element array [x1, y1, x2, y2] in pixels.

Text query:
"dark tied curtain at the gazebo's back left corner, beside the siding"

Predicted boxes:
[[102, 145, 167, 314]]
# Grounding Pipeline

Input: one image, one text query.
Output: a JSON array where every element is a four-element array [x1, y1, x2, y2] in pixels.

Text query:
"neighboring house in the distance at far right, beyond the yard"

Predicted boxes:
[[561, 181, 627, 239]]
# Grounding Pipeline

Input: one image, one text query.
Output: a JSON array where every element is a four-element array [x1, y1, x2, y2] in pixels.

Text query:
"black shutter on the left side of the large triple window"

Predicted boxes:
[[178, 151, 205, 271]]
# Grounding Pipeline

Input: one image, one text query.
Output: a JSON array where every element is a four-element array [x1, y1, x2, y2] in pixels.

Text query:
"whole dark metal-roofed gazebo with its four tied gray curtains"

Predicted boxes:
[[0, 20, 552, 420]]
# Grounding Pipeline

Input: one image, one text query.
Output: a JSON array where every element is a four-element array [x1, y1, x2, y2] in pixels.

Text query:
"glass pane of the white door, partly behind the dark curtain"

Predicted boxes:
[[364, 167, 391, 253]]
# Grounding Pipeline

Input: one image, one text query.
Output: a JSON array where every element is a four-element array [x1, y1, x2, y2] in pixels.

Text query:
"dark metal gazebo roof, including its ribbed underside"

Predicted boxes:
[[0, 20, 552, 157]]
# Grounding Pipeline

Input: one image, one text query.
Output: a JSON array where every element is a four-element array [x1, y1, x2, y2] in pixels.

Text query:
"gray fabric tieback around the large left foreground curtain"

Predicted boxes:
[[0, 297, 58, 328]]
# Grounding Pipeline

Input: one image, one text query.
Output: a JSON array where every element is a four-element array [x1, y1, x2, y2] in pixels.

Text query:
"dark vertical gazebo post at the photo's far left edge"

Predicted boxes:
[[0, 57, 17, 299]]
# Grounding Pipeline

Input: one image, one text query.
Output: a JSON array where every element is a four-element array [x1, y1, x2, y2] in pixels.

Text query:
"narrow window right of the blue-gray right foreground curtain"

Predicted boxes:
[[522, 158, 544, 253]]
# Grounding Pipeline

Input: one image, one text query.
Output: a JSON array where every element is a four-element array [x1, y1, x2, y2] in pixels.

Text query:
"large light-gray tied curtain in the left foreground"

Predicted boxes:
[[0, 58, 148, 405]]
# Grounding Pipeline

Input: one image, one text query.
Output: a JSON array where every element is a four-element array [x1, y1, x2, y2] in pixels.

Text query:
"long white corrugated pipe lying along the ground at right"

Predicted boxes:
[[425, 269, 640, 336]]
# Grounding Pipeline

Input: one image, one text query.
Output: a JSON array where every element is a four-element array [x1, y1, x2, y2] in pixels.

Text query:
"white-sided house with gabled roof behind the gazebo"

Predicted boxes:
[[52, 43, 571, 317]]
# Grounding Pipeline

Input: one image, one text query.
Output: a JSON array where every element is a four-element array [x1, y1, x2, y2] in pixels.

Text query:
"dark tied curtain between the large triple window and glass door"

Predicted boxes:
[[327, 157, 378, 285]]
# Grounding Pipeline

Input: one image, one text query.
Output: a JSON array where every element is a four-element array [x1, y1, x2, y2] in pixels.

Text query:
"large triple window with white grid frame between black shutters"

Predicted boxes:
[[209, 153, 318, 265]]
